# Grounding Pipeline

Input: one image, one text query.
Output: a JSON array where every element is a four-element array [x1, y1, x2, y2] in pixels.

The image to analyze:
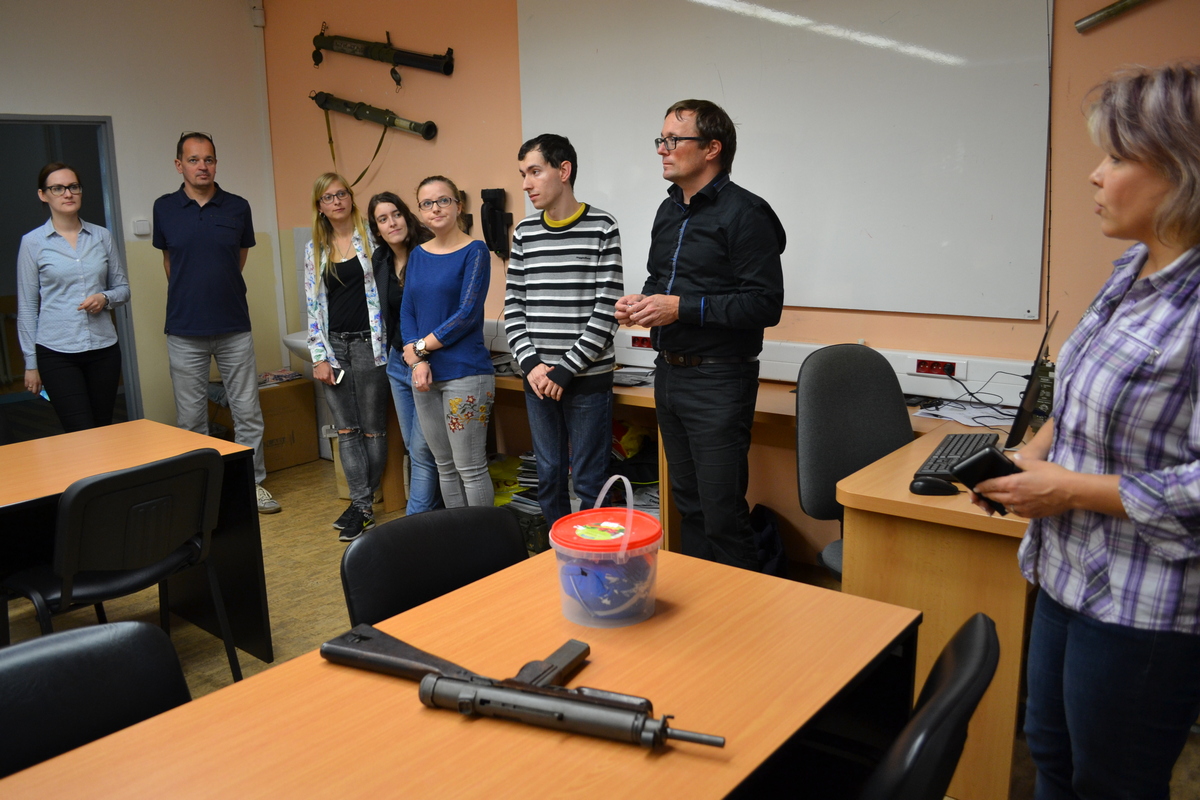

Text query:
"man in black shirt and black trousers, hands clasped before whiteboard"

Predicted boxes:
[[617, 100, 786, 570]]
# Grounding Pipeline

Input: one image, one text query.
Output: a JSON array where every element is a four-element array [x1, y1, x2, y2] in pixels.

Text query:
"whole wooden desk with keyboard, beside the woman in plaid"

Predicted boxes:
[[838, 422, 1031, 800]]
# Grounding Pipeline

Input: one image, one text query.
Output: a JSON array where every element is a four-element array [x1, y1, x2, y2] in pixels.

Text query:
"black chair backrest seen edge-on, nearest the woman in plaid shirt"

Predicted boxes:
[[860, 614, 1000, 800]]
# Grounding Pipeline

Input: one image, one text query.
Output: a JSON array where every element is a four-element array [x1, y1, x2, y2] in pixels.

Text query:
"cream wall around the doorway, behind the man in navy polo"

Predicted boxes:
[[0, 0, 282, 423]]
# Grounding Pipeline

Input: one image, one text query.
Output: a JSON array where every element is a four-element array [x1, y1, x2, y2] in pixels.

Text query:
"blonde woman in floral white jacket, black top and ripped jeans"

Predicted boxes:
[[304, 173, 390, 542]]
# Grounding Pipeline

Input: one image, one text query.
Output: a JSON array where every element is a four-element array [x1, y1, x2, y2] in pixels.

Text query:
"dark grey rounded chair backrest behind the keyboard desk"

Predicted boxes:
[[796, 344, 912, 519]]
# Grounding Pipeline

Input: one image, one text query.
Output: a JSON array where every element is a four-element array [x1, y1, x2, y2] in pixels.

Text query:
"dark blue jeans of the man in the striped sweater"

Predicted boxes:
[[526, 385, 612, 525]]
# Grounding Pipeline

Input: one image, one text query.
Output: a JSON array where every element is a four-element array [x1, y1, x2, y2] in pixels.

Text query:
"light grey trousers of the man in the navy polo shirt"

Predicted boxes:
[[167, 331, 266, 483]]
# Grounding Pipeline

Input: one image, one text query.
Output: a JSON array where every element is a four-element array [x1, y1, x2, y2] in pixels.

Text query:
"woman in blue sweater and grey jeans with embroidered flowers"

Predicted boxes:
[[400, 175, 496, 509]]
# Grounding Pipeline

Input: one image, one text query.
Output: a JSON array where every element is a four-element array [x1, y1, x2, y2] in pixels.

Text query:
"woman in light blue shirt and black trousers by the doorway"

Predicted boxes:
[[17, 162, 130, 433]]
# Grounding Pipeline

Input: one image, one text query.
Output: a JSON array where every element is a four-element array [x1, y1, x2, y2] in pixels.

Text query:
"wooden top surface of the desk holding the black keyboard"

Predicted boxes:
[[838, 422, 1030, 539]]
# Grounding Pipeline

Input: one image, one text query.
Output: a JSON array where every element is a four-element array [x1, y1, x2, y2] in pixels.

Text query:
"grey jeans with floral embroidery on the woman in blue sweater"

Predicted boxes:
[[413, 373, 496, 509]]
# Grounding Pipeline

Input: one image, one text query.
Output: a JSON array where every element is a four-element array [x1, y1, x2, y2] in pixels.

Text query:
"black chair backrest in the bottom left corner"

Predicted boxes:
[[0, 622, 192, 776]]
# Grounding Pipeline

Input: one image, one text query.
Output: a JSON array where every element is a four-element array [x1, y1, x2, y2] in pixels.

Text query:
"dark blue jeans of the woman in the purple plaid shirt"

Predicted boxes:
[[1025, 591, 1200, 800]]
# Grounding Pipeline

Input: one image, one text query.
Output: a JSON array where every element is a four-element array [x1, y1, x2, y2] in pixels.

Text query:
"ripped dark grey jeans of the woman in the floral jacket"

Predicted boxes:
[[325, 333, 391, 513]]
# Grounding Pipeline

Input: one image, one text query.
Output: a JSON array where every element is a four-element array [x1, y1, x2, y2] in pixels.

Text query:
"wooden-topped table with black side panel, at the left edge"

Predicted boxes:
[[0, 420, 275, 661]]
